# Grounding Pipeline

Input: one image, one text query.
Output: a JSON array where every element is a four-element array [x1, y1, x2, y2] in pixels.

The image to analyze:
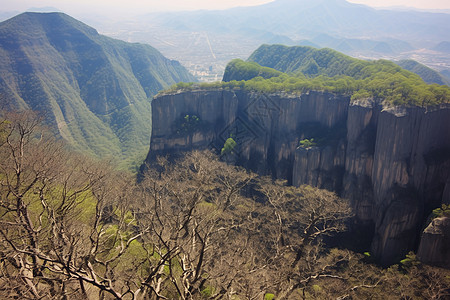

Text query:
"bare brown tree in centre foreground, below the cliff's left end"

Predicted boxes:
[[139, 152, 254, 299]]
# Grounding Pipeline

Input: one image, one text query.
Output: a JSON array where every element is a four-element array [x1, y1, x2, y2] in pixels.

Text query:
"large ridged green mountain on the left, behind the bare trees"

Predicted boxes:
[[0, 13, 195, 169]]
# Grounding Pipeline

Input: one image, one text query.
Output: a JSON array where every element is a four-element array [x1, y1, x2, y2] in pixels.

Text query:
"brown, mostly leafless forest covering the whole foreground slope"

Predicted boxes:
[[0, 112, 450, 299]]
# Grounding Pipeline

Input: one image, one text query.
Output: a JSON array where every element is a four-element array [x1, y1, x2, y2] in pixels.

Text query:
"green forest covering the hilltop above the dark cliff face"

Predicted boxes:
[[166, 45, 450, 106]]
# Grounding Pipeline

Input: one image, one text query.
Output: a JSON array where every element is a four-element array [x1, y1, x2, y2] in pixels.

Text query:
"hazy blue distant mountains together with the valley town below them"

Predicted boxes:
[[92, 0, 450, 80]]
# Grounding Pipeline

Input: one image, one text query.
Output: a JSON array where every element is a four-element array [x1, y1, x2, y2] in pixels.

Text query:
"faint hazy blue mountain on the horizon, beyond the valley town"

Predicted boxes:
[[145, 0, 450, 42]]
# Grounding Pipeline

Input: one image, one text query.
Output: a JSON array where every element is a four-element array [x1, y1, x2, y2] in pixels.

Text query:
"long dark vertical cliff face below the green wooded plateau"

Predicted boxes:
[[147, 90, 450, 264]]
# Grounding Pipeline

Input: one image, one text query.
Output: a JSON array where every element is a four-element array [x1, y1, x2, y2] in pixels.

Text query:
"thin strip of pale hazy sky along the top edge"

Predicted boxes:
[[0, 0, 450, 13]]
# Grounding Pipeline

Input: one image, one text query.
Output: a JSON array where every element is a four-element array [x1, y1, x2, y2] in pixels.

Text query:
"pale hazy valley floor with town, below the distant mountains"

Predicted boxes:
[[102, 23, 450, 82]]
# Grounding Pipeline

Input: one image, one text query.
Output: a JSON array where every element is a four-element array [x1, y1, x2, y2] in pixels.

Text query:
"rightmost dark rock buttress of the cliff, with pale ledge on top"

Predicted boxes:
[[372, 107, 450, 263]]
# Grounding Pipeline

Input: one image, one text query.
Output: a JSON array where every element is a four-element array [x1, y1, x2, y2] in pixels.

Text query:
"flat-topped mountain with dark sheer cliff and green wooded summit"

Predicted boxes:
[[146, 45, 450, 266]]
